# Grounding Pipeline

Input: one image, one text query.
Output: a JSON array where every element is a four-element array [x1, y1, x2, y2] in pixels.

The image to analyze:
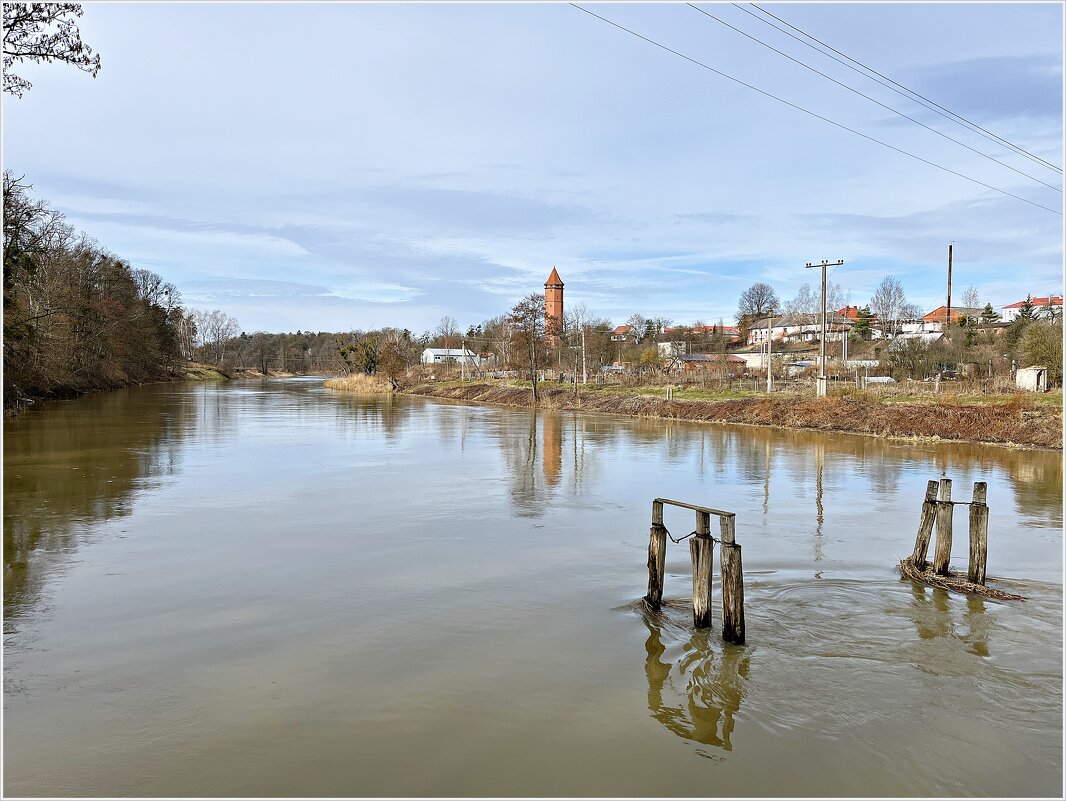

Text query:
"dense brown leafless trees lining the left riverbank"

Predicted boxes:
[[3, 172, 194, 407]]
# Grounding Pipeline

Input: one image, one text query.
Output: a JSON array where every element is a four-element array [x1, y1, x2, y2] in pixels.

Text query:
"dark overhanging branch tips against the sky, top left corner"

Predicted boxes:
[[3, 2, 100, 97]]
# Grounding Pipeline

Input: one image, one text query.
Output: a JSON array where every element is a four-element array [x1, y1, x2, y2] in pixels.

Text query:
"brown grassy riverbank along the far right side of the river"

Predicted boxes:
[[401, 382, 1063, 450]]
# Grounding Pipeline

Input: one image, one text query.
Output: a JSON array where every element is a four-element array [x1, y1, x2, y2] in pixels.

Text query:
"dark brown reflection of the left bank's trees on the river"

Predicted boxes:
[[3, 388, 201, 632]]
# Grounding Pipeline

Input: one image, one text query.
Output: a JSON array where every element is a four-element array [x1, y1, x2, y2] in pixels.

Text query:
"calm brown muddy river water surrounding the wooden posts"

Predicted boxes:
[[3, 380, 1063, 797]]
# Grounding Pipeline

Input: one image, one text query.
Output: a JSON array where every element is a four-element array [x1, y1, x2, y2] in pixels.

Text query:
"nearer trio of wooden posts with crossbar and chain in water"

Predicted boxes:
[[644, 498, 744, 643]]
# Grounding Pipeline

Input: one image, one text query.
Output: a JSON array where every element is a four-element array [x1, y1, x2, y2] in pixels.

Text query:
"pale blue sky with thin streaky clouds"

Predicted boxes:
[[2, 3, 1063, 333]]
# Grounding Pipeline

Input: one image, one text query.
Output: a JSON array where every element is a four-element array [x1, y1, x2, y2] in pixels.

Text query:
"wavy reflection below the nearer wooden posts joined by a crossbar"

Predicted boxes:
[[640, 605, 750, 756]]
